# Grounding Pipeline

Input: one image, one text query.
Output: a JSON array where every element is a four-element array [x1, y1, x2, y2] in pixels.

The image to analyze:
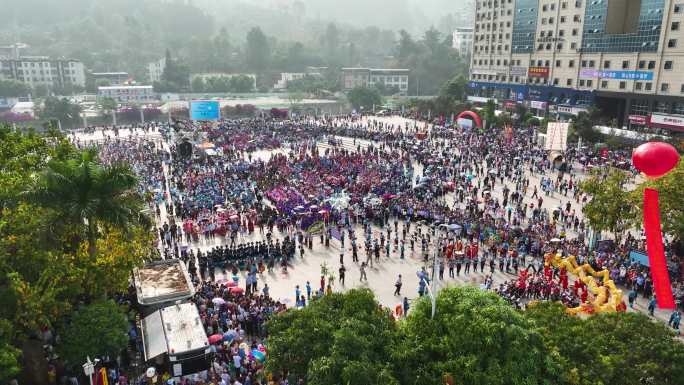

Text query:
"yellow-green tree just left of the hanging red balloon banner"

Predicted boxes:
[[580, 169, 638, 239]]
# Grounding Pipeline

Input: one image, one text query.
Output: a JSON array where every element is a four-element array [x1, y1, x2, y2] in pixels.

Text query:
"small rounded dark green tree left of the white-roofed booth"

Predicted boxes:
[[59, 300, 128, 367]]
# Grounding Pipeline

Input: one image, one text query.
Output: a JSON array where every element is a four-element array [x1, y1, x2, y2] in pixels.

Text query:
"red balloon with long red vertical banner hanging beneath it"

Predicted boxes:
[[632, 142, 679, 309]]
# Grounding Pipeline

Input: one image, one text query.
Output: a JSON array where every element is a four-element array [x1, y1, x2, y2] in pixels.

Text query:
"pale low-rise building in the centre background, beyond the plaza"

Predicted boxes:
[[342, 68, 411, 95]]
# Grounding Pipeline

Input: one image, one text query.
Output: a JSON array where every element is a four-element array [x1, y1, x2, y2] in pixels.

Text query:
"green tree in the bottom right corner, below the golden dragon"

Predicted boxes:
[[524, 302, 684, 385]]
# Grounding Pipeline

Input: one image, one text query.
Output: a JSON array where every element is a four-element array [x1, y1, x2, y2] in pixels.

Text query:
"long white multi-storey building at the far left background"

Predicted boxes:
[[0, 56, 85, 89]]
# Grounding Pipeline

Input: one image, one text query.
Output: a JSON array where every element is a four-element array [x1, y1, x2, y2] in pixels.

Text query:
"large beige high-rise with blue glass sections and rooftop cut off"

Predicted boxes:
[[469, 0, 684, 131]]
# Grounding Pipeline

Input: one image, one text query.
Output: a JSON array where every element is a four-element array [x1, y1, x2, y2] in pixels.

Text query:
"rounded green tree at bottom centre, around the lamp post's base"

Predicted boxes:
[[392, 287, 560, 385]]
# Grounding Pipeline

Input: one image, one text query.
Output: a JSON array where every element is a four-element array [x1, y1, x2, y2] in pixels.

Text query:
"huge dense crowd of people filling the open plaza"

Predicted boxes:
[[60, 116, 684, 384]]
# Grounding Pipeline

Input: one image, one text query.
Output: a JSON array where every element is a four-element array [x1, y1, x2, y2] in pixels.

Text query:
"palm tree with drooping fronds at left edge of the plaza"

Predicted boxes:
[[25, 149, 142, 258]]
